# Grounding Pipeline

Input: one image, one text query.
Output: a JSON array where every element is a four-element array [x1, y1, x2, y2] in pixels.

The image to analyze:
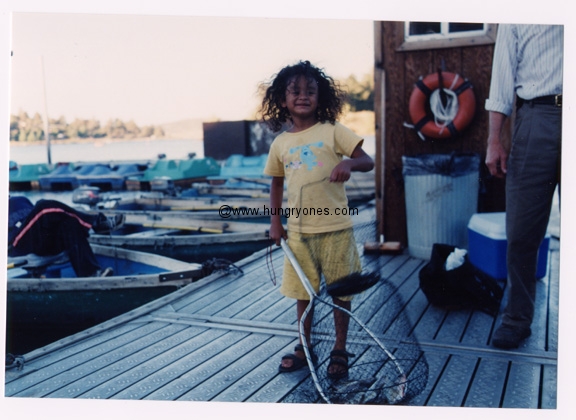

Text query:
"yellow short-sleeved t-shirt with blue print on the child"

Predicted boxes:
[[264, 123, 363, 233]]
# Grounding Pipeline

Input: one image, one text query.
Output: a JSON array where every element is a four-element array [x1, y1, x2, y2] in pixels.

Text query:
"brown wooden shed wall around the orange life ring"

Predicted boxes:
[[374, 22, 504, 244]]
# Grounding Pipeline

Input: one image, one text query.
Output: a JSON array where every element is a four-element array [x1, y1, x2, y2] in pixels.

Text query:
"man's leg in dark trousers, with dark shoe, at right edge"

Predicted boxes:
[[493, 105, 561, 348]]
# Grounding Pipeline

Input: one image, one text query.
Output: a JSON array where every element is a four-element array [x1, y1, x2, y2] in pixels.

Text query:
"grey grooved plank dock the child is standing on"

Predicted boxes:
[[5, 230, 559, 409]]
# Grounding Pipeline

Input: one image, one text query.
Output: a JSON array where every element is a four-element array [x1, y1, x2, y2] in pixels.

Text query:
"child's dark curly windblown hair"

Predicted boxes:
[[260, 61, 346, 131]]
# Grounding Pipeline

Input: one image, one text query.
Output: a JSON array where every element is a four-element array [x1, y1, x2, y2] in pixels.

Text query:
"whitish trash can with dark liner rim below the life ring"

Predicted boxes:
[[402, 153, 480, 260]]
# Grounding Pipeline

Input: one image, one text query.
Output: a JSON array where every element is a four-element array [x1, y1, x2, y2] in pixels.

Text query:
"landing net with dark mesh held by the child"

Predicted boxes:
[[286, 221, 428, 404]]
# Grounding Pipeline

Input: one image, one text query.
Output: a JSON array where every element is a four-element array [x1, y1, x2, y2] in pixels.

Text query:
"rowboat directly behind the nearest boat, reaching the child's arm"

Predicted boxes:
[[88, 210, 270, 261]]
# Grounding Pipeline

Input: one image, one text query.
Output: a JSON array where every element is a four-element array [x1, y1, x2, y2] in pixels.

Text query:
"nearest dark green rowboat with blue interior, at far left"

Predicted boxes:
[[7, 244, 238, 353]]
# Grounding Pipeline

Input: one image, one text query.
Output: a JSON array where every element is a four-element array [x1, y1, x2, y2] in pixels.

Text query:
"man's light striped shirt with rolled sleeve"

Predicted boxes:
[[485, 25, 564, 115]]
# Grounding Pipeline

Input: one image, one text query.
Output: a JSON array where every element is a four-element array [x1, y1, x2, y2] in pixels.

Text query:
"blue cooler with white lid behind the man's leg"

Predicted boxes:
[[468, 213, 550, 280]]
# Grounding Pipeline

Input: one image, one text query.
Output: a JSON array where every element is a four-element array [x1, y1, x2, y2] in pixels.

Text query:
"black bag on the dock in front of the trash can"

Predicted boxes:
[[419, 244, 503, 316]]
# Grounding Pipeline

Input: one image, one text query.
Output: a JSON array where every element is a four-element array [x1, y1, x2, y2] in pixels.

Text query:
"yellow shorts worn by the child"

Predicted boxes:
[[280, 228, 362, 300]]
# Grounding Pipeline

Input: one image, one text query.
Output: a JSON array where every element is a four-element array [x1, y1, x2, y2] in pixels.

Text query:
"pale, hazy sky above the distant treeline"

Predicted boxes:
[[10, 13, 374, 125]]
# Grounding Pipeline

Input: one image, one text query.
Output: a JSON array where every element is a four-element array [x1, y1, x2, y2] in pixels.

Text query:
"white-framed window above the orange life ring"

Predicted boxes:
[[397, 22, 496, 51]]
